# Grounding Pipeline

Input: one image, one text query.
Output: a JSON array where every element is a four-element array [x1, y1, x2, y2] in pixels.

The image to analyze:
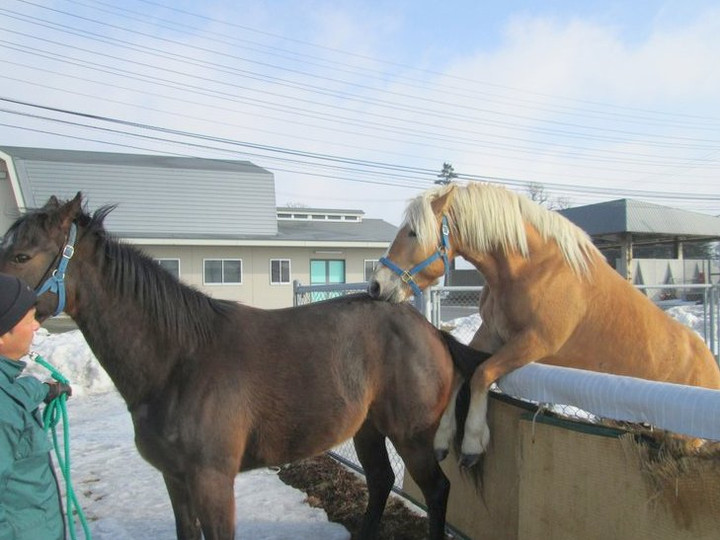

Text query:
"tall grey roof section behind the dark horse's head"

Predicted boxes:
[[0, 146, 277, 237]]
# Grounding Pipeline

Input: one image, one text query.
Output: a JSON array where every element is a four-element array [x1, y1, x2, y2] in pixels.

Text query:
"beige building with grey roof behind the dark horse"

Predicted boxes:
[[0, 147, 396, 308]]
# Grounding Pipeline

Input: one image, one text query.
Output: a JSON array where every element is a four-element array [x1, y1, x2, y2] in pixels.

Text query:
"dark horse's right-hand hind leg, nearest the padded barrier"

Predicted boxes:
[[393, 433, 450, 540]]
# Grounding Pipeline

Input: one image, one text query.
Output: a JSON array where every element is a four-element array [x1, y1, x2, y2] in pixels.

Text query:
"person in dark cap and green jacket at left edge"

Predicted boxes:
[[0, 274, 72, 540]]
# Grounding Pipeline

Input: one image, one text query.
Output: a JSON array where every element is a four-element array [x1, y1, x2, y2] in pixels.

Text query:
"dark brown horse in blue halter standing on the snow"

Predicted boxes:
[[0, 193, 488, 540]]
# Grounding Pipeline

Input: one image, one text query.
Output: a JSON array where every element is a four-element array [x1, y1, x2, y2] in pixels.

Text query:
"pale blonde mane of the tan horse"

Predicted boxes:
[[404, 183, 599, 275]]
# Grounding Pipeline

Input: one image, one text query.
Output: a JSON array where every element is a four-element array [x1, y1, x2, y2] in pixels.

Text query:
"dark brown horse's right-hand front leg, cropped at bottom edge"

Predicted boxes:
[[188, 466, 235, 540]]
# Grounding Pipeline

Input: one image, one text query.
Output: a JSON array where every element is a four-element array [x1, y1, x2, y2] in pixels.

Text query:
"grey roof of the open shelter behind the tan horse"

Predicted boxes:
[[560, 199, 720, 247]]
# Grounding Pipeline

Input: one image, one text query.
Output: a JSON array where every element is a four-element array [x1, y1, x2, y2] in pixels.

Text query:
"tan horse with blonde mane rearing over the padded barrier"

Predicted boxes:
[[369, 184, 720, 465]]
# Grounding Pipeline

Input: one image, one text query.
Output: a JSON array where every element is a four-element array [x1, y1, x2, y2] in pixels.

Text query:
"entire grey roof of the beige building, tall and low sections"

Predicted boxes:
[[0, 146, 397, 247]]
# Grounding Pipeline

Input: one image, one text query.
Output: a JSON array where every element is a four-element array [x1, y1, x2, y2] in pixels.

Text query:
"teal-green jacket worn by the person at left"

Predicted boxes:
[[0, 356, 65, 540]]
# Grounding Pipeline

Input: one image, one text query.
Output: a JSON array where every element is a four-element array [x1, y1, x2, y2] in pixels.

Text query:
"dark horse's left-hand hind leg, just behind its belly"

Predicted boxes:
[[353, 422, 395, 539]]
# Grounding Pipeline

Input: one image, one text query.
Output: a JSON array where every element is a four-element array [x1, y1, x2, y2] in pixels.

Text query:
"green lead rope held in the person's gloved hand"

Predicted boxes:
[[33, 354, 90, 540]]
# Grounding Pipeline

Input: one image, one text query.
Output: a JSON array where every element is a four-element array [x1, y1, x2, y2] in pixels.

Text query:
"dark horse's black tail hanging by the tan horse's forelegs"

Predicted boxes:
[[440, 330, 492, 492]]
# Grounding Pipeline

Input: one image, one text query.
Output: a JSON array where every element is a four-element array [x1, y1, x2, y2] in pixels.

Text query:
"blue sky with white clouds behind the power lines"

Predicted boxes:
[[0, 0, 720, 224]]
